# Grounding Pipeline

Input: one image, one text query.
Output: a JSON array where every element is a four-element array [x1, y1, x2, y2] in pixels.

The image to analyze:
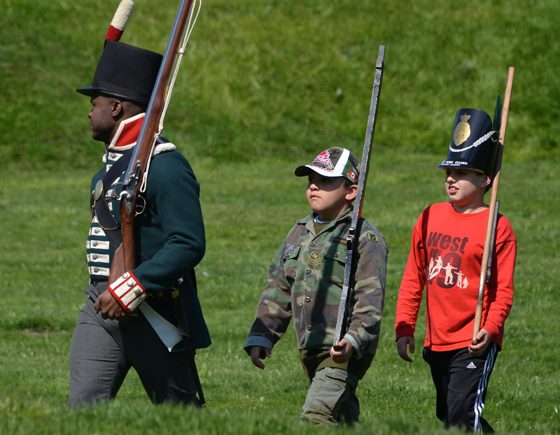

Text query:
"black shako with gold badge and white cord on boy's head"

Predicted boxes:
[[438, 109, 498, 177]]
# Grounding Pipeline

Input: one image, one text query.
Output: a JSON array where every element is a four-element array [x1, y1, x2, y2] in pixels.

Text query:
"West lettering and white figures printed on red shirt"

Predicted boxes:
[[426, 232, 469, 289]]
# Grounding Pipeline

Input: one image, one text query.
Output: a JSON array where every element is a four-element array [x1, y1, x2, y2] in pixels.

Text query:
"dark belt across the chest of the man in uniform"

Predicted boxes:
[[91, 148, 133, 248]]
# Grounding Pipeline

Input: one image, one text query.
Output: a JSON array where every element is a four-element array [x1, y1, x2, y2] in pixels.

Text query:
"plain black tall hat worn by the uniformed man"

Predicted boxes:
[[76, 41, 163, 106]]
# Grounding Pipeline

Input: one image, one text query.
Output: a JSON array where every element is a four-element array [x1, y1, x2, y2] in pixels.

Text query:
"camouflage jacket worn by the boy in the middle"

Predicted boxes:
[[245, 210, 388, 358]]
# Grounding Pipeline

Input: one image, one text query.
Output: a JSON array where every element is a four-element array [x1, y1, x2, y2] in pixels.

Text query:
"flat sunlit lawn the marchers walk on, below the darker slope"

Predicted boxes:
[[0, 151, 560, 433]]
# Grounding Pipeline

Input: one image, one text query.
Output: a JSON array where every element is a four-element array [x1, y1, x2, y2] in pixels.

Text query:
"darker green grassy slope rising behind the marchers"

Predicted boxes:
[[0, 0, 560, 170]]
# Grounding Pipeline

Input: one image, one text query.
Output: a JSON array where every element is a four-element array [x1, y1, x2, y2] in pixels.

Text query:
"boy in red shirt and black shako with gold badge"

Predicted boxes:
[[395, 109, 517, 432]]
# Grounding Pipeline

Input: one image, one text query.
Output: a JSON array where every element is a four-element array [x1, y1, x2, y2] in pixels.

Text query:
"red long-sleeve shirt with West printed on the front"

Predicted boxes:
[[395, 202, 517, 351]]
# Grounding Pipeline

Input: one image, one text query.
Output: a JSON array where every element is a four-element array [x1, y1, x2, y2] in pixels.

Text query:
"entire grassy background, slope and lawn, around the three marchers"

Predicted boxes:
[[0, 0, 560, 434]]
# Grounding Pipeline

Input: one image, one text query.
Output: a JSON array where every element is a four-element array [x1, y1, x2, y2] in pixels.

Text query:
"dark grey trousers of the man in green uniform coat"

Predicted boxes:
[[69, 286, 196, 407]]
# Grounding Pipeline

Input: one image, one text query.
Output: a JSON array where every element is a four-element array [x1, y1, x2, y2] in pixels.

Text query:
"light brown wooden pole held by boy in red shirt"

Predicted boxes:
[[472, 66, 515, 344]]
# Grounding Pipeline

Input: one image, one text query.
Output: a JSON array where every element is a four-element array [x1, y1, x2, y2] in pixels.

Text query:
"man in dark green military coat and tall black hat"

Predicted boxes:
[[69, 41, 210, 407]]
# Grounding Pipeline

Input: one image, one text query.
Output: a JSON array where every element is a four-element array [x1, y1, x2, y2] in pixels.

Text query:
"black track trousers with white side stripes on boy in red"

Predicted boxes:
[[423, 344, 498, 432]]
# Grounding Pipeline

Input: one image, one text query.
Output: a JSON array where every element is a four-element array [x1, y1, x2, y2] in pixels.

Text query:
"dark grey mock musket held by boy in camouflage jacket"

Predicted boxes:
[[333, 45, 385, 346]]
